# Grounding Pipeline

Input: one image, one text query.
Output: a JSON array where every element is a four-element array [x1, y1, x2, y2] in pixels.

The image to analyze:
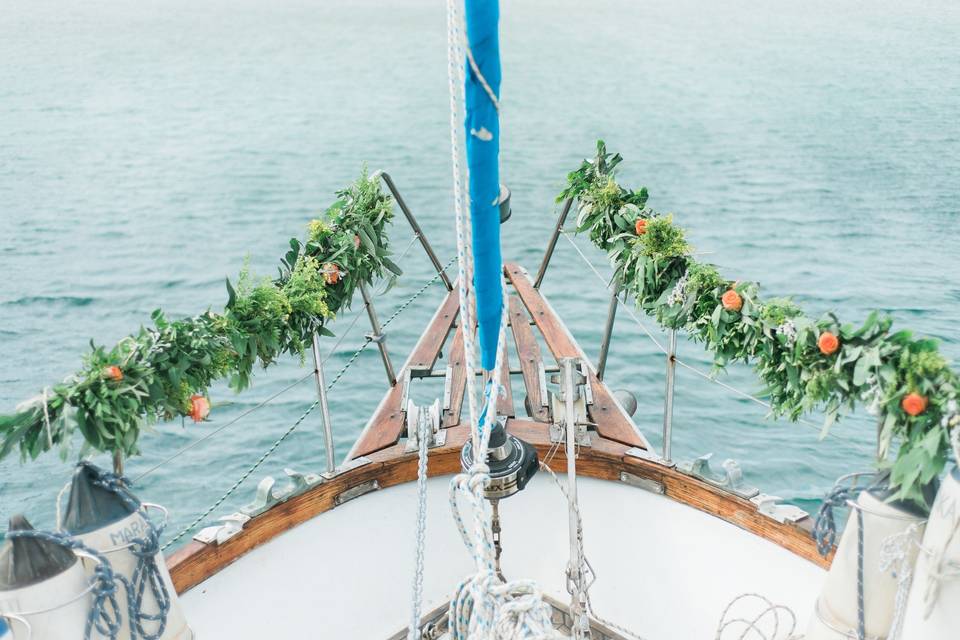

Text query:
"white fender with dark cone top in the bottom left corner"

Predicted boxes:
[[0, 516, 93, 640]]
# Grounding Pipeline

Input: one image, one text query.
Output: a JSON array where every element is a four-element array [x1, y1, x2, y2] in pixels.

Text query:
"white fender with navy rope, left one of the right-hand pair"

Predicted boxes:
[[806, 491, 924, 640]]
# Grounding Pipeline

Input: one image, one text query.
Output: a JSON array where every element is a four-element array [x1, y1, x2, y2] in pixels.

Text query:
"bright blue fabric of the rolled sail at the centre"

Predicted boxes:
[[465, 0, 503, 371]]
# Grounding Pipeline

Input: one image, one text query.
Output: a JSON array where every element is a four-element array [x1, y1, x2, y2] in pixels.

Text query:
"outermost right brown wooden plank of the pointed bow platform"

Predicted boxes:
[[505, 264, 649, 449]]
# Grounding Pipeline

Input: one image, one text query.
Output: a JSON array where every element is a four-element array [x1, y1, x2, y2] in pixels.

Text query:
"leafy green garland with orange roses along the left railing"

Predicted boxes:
[[0, 168, 400, 460]]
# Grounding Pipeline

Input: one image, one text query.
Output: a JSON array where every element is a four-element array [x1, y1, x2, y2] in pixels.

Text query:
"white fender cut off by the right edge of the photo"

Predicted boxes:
[[900, 467, 960, 640]]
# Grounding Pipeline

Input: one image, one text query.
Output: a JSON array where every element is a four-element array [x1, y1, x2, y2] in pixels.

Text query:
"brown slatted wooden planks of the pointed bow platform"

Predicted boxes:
[[349, 264, 649, 459]]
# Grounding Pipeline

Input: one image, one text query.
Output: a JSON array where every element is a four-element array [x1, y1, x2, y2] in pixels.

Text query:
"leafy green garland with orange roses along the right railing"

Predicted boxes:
[[557, 140, 960, 505]]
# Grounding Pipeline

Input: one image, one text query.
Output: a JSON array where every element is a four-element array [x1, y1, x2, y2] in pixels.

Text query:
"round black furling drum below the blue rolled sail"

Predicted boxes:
[[460, 418, 540, 500]]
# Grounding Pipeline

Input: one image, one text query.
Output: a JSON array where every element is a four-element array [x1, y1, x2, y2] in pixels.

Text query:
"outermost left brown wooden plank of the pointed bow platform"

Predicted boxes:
[[349, 288, 460, 458]]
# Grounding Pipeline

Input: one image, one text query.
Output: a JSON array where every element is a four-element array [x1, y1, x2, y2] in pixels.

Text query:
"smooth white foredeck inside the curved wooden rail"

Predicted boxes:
[[182, 472, 825, 640]]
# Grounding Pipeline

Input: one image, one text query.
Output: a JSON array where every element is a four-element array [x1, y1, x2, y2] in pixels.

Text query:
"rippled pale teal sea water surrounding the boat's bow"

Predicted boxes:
[[0, 0, 960, 544]]
